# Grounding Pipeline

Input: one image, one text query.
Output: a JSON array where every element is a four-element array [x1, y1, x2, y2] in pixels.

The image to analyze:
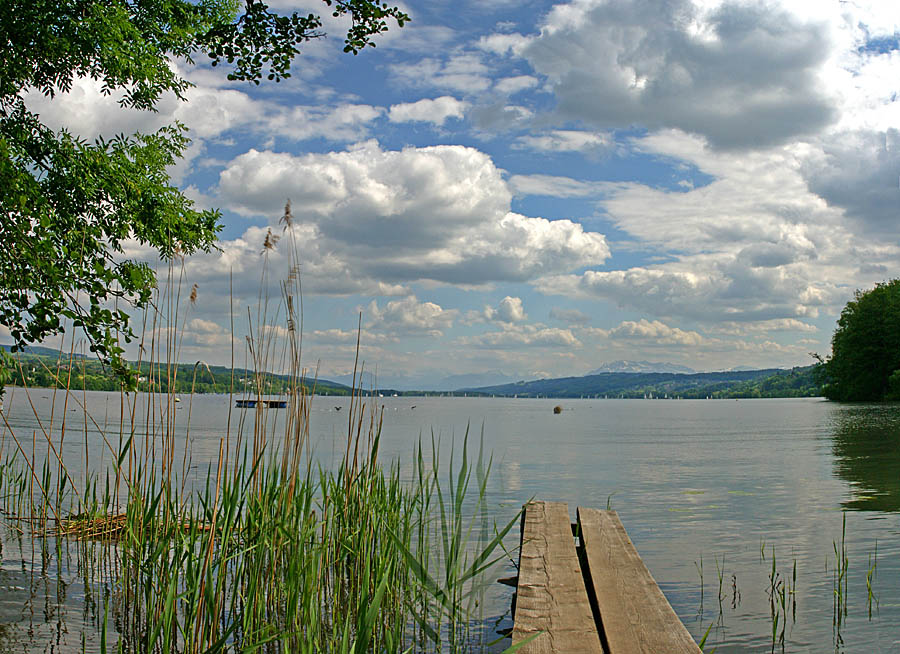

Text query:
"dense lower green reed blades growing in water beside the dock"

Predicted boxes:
[[0, 366, 517, 652]]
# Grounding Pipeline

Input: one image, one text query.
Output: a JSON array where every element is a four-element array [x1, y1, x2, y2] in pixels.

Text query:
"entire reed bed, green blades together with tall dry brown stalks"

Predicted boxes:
[[0, 229, 518, 654]]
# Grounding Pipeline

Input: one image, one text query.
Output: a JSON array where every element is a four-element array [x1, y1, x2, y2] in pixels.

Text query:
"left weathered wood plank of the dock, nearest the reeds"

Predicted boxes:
[[512, 502, 603, 654]]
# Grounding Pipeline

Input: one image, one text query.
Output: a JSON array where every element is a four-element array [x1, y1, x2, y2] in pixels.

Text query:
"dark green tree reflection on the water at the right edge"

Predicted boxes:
[[832, 404, 900, 512]]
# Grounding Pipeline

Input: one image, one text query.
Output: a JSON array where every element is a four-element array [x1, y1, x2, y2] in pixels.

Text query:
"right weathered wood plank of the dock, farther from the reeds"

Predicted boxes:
[[578, 507, 700, 654]]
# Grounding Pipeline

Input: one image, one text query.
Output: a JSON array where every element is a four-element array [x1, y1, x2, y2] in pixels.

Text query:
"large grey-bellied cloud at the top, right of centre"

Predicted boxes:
[[520, 0, 836, 148]]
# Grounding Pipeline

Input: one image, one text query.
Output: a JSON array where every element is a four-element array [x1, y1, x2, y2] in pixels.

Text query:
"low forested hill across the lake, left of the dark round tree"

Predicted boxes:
[[463, 366, 821, 399]]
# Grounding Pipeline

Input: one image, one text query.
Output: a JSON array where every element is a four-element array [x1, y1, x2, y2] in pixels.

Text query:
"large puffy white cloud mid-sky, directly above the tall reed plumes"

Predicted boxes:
[[219, 142, 609, 285]]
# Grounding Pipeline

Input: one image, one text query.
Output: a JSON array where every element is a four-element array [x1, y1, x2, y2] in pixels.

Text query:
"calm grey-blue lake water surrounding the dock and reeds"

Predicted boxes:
[[0, 391, 900, 653]]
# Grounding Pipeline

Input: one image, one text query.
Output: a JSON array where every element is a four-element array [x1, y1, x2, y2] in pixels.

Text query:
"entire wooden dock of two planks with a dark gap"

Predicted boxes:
[[512, 502, 700, 654]]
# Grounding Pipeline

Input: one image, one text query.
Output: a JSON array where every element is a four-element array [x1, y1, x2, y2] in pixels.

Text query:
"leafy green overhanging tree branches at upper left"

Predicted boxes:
[[0, 0, 409, 392]]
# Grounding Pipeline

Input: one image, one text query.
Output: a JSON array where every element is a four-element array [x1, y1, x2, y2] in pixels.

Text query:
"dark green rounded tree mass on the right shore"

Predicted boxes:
[[823, 279, 900, 402]]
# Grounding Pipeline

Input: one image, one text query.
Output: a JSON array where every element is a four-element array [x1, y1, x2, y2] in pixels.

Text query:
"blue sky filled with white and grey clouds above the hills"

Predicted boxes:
[[17, 0, 900, 388]]
